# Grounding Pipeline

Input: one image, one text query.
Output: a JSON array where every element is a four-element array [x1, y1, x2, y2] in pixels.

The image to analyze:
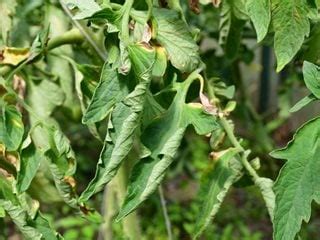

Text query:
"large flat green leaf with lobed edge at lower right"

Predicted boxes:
[[271, 118, 320, 240]]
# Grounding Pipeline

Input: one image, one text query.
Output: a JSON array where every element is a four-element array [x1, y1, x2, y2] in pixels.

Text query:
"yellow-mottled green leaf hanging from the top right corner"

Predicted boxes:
[[272, 0, 317, 72]]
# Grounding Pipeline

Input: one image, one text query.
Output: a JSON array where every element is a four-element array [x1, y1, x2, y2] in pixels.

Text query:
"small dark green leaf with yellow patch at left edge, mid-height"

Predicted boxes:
[[0, 106, 24, 151]]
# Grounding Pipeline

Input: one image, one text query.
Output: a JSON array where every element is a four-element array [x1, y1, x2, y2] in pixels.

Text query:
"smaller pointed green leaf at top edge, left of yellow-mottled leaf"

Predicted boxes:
[[246, 0, 271, 42]]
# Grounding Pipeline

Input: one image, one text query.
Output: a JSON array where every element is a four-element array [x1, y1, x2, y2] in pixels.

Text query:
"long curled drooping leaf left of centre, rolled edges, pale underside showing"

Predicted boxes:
[[80, 84, 150, 202]]
